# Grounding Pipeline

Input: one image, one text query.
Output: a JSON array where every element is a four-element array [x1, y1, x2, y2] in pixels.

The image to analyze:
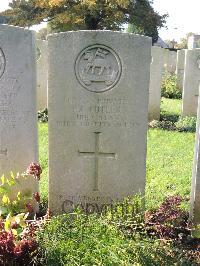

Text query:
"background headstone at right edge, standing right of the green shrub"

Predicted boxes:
[[182, 49, 200, 116]]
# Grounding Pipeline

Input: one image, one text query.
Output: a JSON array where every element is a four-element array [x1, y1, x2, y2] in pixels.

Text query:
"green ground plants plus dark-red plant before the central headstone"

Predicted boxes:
[[36, 196, 198, 266]]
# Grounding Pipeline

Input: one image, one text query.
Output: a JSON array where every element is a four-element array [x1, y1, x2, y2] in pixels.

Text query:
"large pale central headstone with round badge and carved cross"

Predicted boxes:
[[48, 31, 151, 213]]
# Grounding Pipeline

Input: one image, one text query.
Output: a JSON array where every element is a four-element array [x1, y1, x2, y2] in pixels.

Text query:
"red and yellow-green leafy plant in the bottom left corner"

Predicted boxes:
[[0, 163, 42, 265]]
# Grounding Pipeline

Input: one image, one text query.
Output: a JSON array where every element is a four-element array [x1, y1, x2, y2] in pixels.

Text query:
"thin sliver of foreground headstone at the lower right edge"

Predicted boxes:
[[190, 91, 200, 229]]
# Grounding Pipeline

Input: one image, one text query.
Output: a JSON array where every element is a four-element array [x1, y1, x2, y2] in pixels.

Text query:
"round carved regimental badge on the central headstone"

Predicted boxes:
[[75, 45, 122, 92]]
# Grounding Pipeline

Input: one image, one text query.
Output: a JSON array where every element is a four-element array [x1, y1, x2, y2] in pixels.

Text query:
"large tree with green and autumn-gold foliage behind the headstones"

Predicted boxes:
[[2, 0, 167, 41]]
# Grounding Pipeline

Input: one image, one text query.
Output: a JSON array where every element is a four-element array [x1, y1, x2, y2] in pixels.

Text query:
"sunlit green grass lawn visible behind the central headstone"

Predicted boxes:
[[39, 98, 195, 209]]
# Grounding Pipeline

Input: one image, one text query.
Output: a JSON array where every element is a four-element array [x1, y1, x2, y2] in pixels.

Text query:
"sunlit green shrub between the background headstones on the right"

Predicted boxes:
[[161, 73, 182, 99]]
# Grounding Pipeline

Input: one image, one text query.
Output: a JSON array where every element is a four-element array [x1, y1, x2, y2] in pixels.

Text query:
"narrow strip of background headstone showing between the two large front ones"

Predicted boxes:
[[36, 40, 48, 110]]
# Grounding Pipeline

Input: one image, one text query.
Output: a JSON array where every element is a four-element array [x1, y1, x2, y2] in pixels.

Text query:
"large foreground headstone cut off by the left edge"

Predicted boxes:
[[0, 25, 38, 195]]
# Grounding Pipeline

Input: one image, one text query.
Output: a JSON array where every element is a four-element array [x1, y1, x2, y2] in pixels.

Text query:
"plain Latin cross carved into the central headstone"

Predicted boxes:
[[78, 132, 116, 191]]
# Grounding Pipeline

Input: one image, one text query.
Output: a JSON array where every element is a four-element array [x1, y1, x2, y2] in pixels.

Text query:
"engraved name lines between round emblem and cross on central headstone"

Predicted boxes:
[[55, 97, 140, 131]]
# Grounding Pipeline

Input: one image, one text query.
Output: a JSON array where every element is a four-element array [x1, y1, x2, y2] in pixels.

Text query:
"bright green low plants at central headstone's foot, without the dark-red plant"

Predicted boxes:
[[38, 201, 180, 266]]
